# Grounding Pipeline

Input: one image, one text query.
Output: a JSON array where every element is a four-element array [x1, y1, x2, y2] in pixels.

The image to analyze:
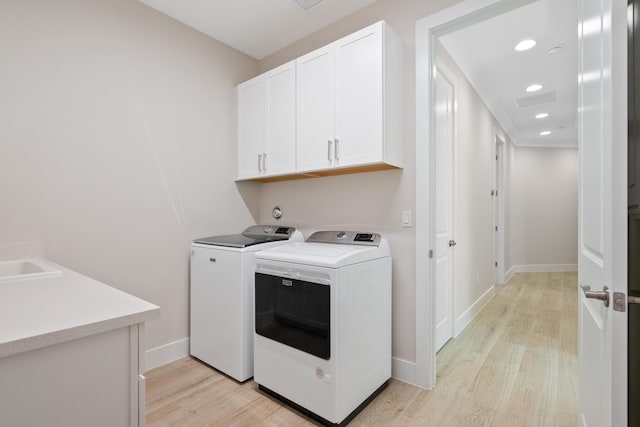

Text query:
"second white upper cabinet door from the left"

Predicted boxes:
[[263, 61, 296, 176]]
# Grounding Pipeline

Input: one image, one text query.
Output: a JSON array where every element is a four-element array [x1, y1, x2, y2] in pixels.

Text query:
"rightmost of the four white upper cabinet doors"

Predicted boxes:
[[335, 23, 384, 166]]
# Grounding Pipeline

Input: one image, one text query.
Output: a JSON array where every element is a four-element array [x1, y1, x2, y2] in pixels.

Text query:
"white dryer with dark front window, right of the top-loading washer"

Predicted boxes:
[[254, 231, 391, 425]]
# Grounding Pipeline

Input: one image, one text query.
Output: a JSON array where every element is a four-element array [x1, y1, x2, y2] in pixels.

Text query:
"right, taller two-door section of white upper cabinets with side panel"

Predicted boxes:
[[296, 22, 403, 172]]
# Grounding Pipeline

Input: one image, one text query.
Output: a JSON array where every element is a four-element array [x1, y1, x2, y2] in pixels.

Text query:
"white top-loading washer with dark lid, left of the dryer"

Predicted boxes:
[[189, 225, 303, 382]]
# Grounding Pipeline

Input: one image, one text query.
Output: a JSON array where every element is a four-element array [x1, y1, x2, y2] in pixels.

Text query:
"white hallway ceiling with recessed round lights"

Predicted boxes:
[[440, 0, 578, 147]]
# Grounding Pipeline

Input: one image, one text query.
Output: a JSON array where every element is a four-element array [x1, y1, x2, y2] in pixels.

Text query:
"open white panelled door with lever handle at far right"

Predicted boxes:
[[578, 0, 627, 427]]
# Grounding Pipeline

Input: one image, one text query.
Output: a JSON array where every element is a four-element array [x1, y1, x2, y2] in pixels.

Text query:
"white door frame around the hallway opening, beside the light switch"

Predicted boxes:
[[414, 0, 535, 389]]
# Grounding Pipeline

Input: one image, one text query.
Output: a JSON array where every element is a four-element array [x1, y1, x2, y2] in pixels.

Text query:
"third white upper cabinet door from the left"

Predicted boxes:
[[296, 45, 335, 172]]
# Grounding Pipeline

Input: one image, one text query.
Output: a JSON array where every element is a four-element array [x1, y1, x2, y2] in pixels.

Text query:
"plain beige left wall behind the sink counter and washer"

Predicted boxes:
[[0, 0, 258, 358]]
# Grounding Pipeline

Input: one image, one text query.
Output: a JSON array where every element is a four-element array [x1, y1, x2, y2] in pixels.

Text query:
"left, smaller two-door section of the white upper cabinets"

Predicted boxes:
[[237, 61, 296, 179]]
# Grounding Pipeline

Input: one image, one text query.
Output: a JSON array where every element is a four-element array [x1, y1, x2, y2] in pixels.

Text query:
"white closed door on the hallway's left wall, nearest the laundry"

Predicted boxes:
[[434, 68, 455, 351]]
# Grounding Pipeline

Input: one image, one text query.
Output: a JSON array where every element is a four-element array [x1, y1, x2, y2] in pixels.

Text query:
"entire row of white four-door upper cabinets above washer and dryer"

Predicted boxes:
[[238, 21, 403, 181]]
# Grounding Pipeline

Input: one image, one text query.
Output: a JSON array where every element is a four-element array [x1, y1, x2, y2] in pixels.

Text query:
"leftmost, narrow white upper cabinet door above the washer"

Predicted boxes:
[[237, 76, 265, 179]]
